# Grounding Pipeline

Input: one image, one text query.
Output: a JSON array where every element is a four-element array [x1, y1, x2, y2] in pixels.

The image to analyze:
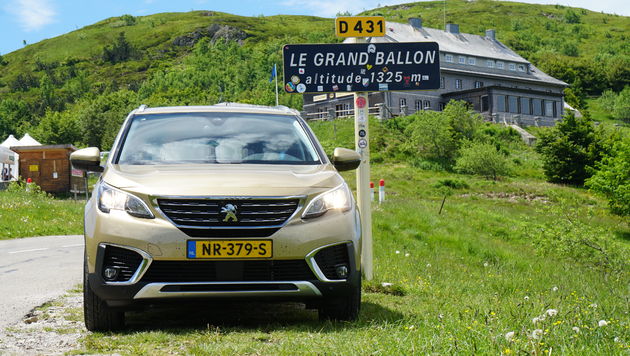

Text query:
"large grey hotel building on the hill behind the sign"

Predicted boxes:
[[303, 18, 568, 126]]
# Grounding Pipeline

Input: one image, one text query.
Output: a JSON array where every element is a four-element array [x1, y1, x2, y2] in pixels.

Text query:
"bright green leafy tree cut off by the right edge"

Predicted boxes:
[[586, 135, 630, 215]]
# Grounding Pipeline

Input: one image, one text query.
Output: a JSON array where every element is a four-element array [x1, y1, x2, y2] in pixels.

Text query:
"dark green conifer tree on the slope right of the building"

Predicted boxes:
[[536, 112, 605, 185]]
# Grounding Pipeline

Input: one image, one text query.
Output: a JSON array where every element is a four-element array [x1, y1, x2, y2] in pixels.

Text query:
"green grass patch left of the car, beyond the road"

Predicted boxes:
[[0, 184, 85, 240]]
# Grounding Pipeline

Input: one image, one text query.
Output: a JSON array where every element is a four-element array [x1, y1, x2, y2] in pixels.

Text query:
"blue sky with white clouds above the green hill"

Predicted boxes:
[[0, 0, 630, 54]]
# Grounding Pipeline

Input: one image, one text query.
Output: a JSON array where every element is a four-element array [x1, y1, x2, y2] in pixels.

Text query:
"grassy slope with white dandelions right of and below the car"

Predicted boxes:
[[75, 163, 630, 355]]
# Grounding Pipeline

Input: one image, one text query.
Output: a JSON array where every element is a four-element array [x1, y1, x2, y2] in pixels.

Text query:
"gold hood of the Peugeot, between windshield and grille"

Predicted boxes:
[[103, 164, 343, 196]]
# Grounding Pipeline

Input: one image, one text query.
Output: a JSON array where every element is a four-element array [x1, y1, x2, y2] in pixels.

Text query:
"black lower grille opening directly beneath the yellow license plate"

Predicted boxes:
[[142, 260, 315, 283]]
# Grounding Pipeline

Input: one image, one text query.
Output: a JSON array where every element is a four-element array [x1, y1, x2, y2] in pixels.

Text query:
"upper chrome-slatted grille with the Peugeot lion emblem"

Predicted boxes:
[[157, 198, 300, 237]]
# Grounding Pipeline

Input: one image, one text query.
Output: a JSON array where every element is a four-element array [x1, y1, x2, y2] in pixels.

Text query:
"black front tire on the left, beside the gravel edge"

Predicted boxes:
[[83, 262, 125, 331]]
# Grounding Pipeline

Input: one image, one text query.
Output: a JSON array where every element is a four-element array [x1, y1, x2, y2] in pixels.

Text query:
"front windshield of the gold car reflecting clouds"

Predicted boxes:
[[118, 113, 320, 165]]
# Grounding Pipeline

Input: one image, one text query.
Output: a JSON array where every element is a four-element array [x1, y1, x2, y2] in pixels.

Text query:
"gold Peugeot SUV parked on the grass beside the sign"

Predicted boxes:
[[71, 104, 361, 330]]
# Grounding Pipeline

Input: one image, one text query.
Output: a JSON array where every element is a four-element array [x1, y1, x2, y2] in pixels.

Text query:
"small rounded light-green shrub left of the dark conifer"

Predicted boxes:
[[455, 142, 510, 180]]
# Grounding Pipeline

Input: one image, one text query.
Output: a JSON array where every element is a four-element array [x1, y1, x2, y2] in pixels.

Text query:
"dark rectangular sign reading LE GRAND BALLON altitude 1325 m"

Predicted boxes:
[[283, 42, 440, 93]]
